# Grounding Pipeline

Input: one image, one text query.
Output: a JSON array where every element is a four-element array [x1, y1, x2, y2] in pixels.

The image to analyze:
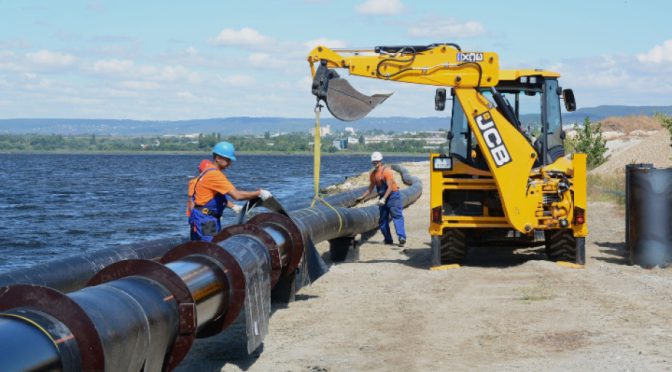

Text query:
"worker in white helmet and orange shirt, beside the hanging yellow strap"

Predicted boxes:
[[357, 151, 406, 245]]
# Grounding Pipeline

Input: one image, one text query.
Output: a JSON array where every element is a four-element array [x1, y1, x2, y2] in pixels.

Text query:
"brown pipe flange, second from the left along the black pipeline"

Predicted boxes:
[[86, 259, 198, 371]]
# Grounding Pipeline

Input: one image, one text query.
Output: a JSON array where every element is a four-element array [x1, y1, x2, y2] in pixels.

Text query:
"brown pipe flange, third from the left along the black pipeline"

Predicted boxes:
[[160, 242, 245, 338]]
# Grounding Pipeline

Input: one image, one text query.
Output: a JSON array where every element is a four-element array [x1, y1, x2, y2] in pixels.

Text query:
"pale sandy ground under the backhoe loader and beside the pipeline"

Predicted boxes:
[[180, 163, 672, 371]]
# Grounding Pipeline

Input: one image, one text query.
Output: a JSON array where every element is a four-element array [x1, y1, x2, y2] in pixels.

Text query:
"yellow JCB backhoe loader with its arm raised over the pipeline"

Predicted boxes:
[[308, 43, 588, 266]]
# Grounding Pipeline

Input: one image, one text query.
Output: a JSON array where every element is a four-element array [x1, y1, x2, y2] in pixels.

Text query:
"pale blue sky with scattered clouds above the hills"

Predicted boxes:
[[0, 0, 672, 120]]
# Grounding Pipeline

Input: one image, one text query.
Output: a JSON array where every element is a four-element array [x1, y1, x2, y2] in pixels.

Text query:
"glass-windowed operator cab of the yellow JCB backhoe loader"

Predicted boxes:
[[450, 70, 575, 169]]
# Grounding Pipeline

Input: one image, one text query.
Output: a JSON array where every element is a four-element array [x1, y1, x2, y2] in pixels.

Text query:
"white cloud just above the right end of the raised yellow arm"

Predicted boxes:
[[408, 18, 485, 39]]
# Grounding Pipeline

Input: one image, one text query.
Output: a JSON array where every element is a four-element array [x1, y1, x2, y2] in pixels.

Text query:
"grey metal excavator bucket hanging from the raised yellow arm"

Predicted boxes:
[[313, 64, 392, 121]]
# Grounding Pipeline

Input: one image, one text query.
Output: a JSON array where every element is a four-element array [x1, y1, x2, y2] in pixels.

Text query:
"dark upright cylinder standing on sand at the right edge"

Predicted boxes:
[[626, 164, 672, 267]]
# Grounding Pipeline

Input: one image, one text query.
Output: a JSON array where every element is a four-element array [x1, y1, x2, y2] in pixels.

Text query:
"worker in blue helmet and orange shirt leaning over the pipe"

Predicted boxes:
[[189, 141, 272, 241]]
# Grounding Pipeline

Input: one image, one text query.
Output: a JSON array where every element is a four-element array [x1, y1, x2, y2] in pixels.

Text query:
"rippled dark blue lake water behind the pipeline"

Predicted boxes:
[[0, 154, 426, 272]]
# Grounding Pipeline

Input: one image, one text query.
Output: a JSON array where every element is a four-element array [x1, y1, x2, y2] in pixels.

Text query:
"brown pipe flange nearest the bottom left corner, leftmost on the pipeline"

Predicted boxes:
[[0, 284, 105, 371]]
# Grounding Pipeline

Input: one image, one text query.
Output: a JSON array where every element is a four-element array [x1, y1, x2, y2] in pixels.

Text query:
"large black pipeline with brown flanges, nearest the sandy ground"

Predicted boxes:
[[0, 165, 421, 371]]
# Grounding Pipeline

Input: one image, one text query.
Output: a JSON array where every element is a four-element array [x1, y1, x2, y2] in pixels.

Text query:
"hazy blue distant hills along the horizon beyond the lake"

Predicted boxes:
[[0, 106, 672, 136]]
